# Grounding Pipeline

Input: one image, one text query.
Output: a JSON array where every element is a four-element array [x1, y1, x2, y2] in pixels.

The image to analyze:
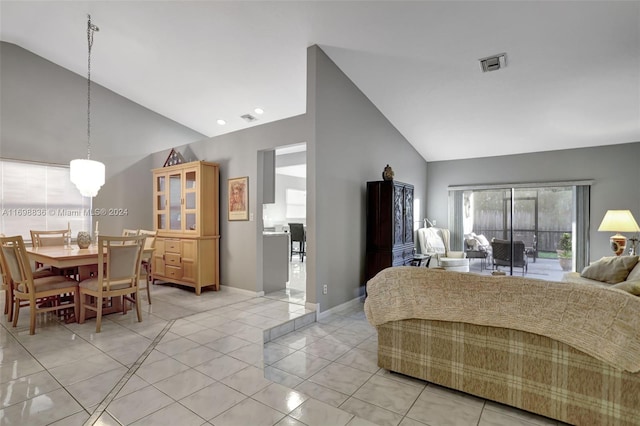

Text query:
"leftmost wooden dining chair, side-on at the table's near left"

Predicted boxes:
[[0, 235, 78, 334]]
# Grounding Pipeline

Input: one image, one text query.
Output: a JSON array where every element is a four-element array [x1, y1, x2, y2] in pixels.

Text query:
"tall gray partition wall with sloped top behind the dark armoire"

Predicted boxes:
[[307, 46, 427, 311]]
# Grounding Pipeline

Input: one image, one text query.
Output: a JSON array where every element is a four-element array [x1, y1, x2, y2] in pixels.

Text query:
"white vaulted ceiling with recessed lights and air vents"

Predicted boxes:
[[0, 0, 640, 161]]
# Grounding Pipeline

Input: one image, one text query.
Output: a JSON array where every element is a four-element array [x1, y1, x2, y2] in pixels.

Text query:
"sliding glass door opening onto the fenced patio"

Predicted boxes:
[[449, 184, 590, 280]]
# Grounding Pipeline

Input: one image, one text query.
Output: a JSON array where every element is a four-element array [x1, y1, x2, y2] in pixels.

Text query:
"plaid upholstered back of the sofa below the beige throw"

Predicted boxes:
[[377, 319, 640, 425]]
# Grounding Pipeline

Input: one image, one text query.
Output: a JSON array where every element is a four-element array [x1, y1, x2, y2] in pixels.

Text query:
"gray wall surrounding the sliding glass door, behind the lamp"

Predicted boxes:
[[427, 142, 640, 260]]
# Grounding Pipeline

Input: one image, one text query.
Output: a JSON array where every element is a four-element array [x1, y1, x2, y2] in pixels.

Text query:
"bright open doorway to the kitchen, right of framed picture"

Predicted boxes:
[[262, 143, 307, 305]]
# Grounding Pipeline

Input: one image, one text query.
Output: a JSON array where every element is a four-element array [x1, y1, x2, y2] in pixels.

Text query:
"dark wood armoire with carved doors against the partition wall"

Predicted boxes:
[[365, 180, 415, 281]]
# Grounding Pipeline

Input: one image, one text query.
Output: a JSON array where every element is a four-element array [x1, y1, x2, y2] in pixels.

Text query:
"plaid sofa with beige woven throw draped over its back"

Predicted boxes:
[[364, 267, 640, 425]]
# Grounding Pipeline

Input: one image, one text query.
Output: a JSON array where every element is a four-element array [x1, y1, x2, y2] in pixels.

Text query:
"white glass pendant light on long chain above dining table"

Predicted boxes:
[[69, 15, 105, 197]]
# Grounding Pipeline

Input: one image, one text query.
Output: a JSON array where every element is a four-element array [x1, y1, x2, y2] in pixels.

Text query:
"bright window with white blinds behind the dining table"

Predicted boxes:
[[0, 160, 92, 241]]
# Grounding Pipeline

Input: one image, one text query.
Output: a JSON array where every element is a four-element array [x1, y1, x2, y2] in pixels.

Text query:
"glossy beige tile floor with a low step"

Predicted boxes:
[[0, 285, 568, 426]]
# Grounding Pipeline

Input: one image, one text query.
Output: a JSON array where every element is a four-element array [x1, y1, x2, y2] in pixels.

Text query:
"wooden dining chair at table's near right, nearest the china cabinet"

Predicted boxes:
[[78, 235, 147, 333]]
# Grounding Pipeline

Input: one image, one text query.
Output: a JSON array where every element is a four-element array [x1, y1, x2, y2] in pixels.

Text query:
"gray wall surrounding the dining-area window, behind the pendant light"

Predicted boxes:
[[0, 42, 204, 234]]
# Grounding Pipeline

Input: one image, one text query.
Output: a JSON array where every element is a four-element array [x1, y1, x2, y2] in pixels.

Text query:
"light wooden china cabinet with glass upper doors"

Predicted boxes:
[[152, 161, 220, 295]]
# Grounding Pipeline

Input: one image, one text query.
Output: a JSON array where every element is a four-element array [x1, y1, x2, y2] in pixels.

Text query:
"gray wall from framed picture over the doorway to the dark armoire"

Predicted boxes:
[[153, 46, 427, 311]]
